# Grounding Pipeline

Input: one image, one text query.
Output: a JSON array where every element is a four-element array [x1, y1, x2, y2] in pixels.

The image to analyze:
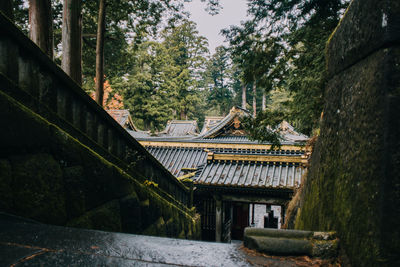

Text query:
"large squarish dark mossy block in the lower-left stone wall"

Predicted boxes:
[[11, 154, 66, 224]]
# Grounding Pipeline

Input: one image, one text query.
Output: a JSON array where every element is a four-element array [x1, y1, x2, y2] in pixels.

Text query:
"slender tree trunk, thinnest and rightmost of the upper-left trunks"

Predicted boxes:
[[96, 0, 106, 106]]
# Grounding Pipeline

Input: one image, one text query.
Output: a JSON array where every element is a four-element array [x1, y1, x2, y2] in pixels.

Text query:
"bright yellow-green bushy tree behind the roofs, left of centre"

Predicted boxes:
[[114, 42, 178, 130]]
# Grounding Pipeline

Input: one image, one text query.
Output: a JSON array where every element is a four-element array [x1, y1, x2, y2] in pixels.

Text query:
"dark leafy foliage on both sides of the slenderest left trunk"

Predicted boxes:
[[82, 0, 188, 91]]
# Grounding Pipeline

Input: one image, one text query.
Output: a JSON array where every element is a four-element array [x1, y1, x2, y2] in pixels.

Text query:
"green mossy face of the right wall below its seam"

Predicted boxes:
[[295, 45, 400, 266]]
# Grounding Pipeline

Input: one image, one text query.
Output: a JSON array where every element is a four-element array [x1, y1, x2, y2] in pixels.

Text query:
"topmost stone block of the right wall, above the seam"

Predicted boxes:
[[327, 0, 400, 77]]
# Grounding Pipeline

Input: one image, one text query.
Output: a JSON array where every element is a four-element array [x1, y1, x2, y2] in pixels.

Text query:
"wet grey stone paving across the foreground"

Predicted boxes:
[[0, 214, 338, 266]]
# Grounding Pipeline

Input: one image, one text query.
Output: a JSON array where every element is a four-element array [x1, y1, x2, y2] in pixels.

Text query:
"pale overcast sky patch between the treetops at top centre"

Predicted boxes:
[[185, 0, 247, 54]]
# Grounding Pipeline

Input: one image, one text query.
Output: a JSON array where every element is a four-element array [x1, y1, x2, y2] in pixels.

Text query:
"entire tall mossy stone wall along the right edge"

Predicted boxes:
[[295, 0, 400, 266]]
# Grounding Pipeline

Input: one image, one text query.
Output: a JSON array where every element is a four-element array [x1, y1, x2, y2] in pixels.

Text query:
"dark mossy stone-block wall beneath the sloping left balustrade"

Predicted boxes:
[[0, 90, 200, 239]]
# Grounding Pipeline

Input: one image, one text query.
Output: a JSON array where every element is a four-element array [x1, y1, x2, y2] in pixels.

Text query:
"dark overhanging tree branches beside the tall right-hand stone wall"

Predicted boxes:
[[223, 0, 348, 134]]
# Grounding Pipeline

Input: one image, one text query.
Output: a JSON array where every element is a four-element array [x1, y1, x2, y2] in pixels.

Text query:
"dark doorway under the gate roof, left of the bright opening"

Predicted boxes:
[[232, 203, 249, 240]]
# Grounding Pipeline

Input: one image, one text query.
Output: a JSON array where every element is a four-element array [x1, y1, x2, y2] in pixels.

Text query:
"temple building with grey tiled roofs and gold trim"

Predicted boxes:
[[108, 107, 308, 242]]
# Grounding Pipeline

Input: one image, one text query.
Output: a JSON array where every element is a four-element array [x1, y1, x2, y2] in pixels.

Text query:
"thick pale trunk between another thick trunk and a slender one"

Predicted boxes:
[[61, 0, 82, 86]]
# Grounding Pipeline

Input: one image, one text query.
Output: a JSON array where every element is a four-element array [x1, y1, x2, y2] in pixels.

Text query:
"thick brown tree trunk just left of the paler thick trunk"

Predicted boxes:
[[29, 0, 54, 59]]
